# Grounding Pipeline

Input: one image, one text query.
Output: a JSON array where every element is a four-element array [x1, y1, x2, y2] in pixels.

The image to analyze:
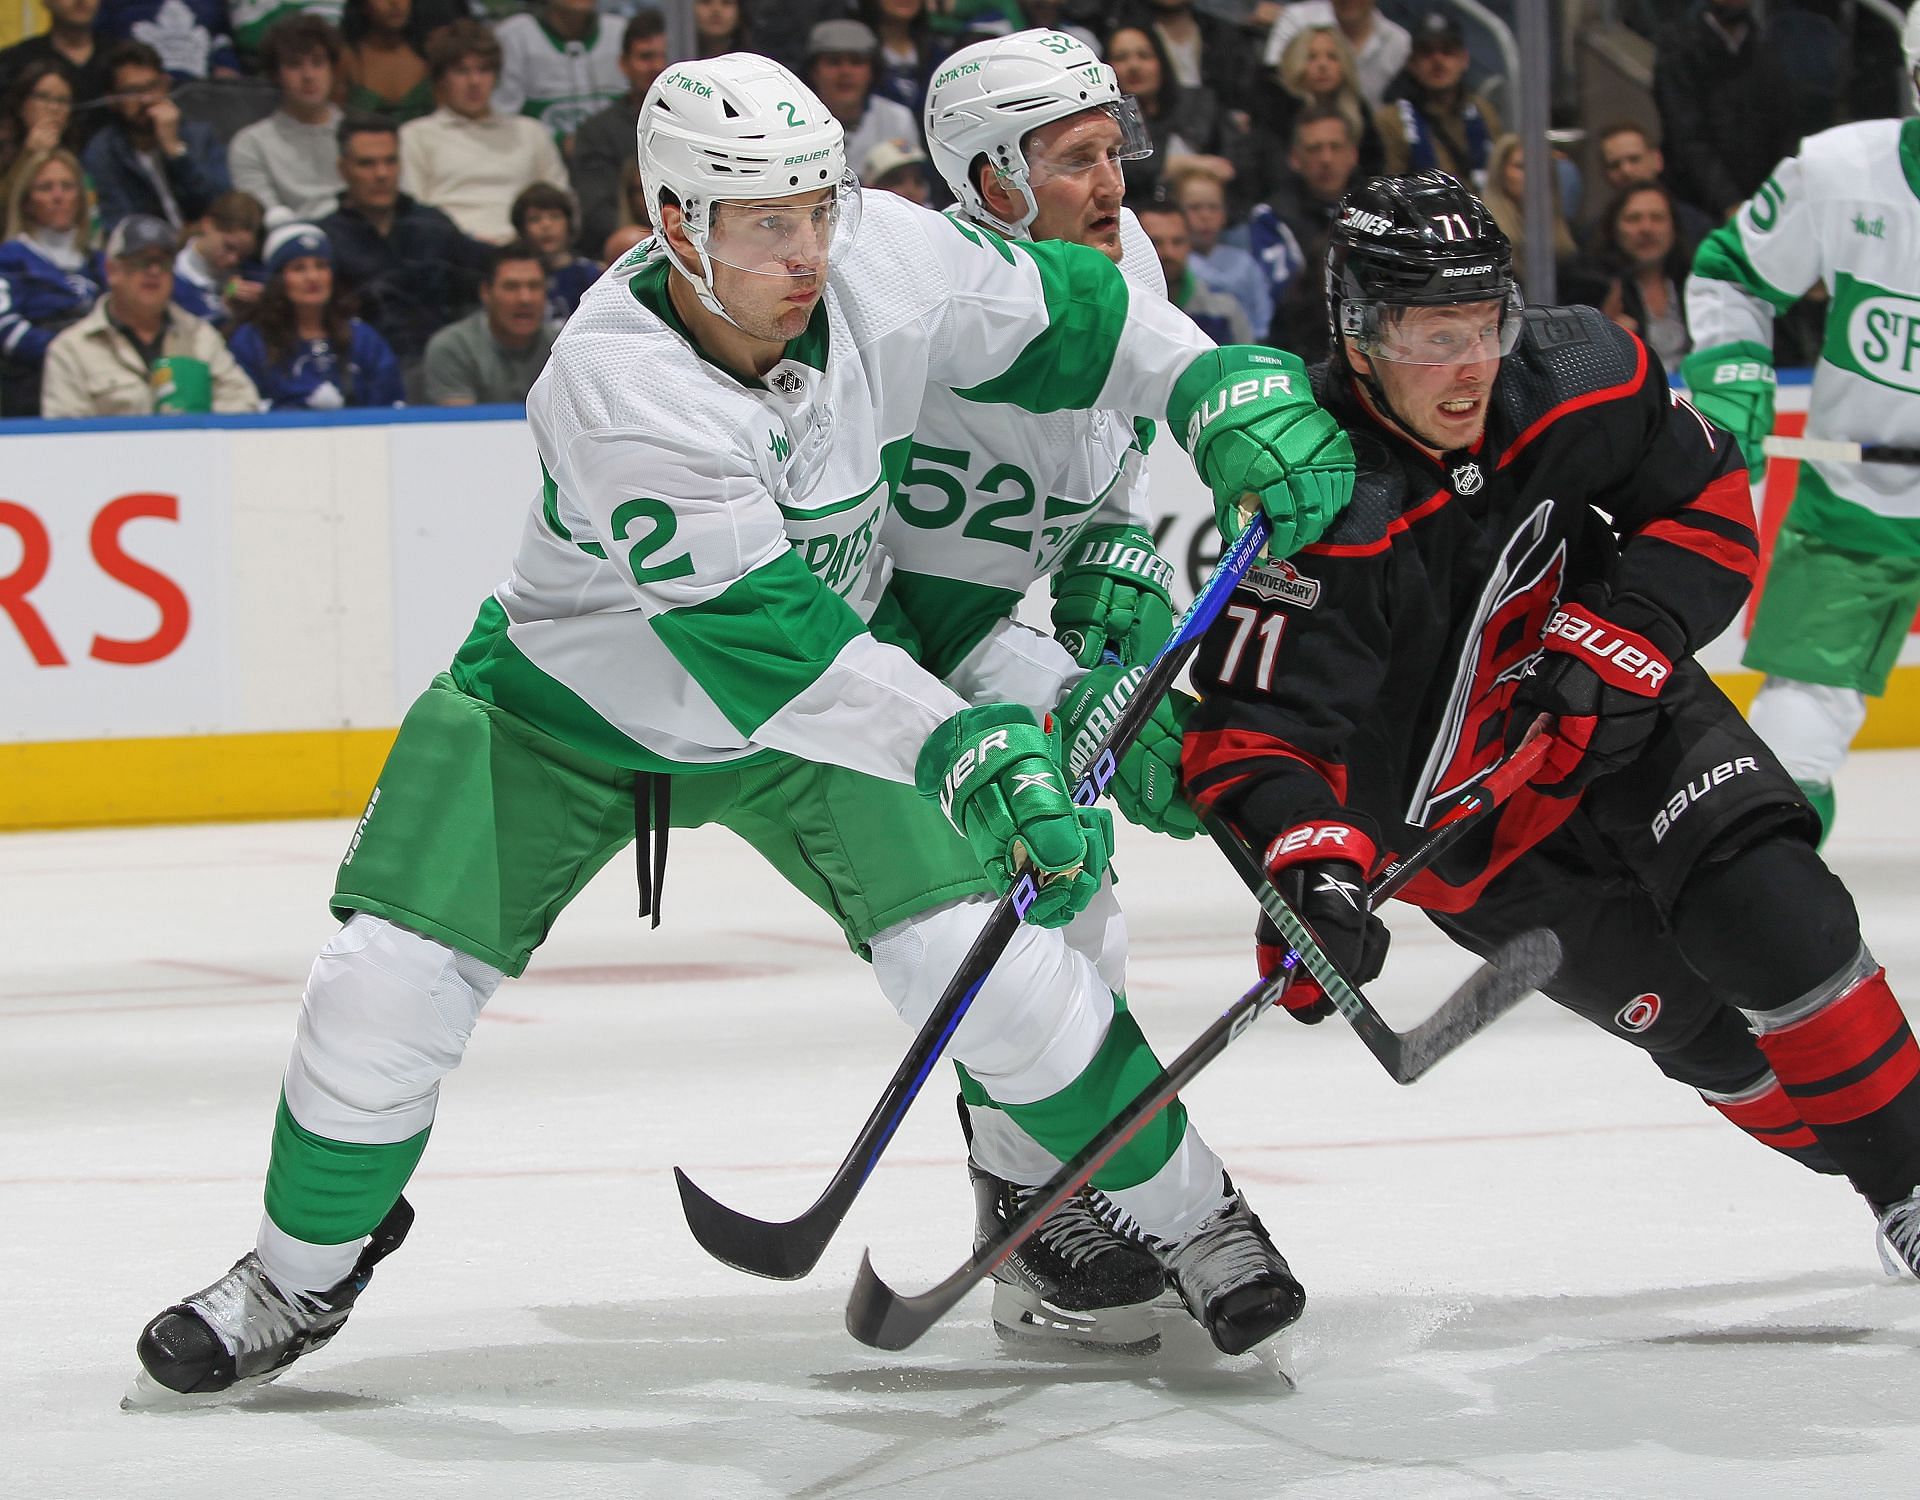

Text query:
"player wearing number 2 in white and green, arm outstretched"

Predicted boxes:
[[127, 54, 1352, 1394]]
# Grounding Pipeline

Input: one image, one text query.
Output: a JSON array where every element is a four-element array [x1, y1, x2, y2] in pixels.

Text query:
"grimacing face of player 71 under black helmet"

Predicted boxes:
[[1371, 302, 1501, 453]]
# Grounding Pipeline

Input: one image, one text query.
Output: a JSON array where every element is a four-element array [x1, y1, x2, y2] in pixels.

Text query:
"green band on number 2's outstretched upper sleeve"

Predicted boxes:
[[954, 240, 1129, 411]]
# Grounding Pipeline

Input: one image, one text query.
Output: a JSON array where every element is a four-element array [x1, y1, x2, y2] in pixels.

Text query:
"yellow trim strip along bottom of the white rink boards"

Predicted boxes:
[[0, 665, 1920, 830]]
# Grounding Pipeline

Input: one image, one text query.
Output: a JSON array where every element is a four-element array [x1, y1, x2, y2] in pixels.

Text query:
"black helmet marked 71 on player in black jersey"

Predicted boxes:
[[1327, 171, 1521, 363]]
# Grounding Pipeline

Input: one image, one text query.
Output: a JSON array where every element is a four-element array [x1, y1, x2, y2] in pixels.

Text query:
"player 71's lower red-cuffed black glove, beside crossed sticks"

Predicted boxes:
[[1254, 818, 1388, 1026]]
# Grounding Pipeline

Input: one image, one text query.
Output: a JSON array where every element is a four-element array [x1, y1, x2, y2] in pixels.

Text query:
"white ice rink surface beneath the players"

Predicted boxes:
[[0, 753, 1920, 1500]]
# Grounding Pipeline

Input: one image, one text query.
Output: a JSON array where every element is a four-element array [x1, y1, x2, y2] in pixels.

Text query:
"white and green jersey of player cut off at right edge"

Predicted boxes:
[[1686, 119, 1920, 553]]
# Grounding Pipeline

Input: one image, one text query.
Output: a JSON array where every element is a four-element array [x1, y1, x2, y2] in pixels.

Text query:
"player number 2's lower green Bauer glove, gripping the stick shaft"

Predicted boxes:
[[914, 703, 1114, 928]]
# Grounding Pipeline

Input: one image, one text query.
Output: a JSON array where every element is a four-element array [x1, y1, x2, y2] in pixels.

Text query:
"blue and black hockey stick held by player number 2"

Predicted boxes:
[[674, 515, 1271, 1281]]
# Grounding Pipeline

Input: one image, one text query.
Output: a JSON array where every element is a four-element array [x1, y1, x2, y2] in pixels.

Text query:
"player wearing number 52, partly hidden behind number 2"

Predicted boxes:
[[881, 29, 1221, 1343]]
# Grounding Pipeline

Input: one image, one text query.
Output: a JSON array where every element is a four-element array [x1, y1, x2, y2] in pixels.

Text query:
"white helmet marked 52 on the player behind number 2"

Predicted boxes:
[[925, 29, 1154, 238]]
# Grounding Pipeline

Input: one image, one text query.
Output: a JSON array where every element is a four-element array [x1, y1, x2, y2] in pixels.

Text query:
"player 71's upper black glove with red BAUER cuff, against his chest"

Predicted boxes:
[[1507, 586, 1686, 797]]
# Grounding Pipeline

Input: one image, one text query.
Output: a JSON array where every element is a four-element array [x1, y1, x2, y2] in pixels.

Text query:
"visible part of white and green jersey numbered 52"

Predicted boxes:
[[881, 209, 1185, 676]]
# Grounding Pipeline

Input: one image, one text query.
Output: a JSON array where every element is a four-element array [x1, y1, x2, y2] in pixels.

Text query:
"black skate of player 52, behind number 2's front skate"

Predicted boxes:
[[968, 1160, 1167, 1354]]
